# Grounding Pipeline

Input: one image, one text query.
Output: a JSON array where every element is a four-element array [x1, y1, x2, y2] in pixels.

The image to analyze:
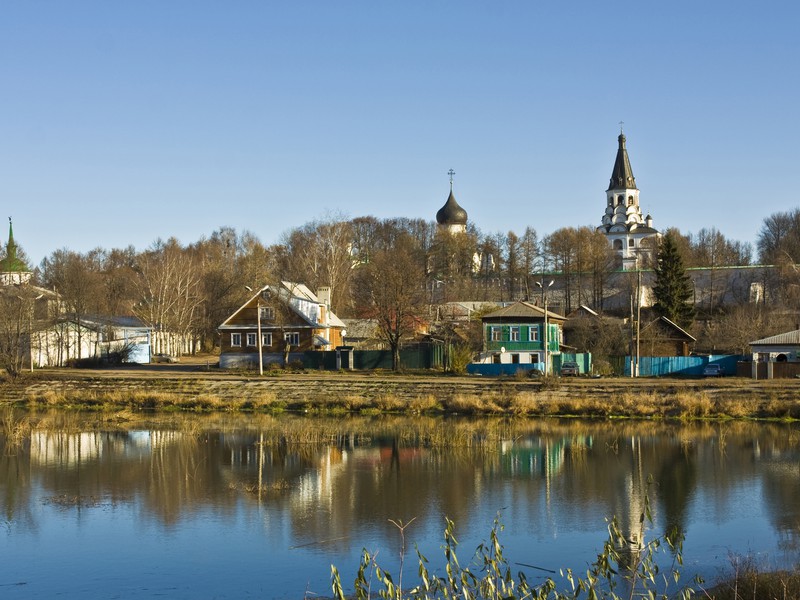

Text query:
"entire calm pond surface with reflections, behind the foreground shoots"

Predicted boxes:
[[0, 411, 800, 598]]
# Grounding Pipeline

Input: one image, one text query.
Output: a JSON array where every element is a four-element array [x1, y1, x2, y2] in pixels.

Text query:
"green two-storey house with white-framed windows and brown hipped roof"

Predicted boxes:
[[472, 302, 565, 364]]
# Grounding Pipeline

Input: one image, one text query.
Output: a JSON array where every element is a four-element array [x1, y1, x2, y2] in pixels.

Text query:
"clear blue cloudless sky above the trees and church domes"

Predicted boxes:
[[0, 0, 800, 264]]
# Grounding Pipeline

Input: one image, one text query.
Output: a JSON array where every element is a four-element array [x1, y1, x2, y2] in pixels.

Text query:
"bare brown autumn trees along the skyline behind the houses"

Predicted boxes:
[[6, 209, 800, 352]]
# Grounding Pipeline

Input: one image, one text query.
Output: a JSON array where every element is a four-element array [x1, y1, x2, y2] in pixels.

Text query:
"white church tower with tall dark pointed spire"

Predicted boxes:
[[597, 133, 660, 271]]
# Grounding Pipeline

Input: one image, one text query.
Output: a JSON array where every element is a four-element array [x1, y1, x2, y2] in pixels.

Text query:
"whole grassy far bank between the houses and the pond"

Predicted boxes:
[[0, 371, 800, 420]]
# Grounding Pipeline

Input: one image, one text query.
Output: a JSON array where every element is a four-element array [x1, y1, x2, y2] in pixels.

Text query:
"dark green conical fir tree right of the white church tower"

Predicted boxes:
[[653, 233, 694, 328]]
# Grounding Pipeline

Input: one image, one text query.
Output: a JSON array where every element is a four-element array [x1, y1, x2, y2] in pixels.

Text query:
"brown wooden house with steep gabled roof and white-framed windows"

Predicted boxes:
[[219, 281, 345, 368]]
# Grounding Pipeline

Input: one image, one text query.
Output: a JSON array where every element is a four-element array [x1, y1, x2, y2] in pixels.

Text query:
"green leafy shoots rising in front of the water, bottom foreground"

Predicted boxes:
[[331, 498, 700, 600]]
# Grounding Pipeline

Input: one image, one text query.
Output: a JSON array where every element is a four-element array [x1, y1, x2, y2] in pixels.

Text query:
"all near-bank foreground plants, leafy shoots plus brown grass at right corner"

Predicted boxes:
[[331, 512, 800, 600]]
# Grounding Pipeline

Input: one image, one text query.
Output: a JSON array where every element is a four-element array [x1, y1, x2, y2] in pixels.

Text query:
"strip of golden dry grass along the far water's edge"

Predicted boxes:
[[10, 381, 800, 420]]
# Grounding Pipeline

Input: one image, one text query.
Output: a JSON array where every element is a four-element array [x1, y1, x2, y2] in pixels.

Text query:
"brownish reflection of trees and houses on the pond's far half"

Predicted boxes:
[[0, 413, 800, 548]]
